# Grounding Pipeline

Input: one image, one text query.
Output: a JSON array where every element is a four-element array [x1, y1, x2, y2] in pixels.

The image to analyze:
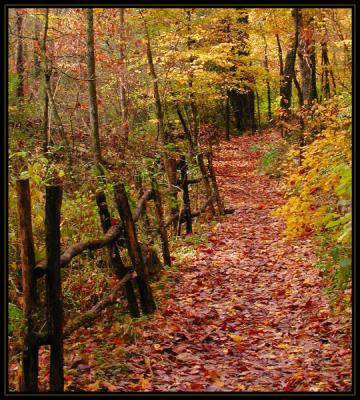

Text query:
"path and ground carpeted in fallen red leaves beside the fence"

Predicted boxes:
[[31, 130, 352, 392]]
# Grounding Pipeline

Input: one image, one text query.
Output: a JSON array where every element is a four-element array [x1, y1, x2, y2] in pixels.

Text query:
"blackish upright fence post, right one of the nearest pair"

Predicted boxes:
[[45, 185, 64, 392]]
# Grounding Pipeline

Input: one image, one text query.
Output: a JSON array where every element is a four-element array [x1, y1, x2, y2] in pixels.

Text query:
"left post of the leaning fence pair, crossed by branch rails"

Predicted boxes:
[[96, 191, 140, 317]]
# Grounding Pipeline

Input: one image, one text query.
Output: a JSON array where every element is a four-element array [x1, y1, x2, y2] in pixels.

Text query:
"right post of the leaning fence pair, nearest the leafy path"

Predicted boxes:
[[114, 183, 156, 314]]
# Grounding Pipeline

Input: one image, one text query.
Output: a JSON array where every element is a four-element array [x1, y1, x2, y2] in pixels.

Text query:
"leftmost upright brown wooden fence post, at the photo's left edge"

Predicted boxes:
[[16, 179, 39, 393]]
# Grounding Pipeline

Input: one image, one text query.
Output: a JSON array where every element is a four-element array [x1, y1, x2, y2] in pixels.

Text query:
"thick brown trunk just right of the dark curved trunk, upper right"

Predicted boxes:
[[296, 9, 317, 107]]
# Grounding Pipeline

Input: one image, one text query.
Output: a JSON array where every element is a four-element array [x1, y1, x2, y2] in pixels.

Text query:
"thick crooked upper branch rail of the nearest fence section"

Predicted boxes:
[[33, 225, 120, 278]]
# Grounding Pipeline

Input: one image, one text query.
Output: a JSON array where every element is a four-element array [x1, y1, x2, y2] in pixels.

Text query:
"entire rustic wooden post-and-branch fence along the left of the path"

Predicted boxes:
[[17, 156, 222, 393]]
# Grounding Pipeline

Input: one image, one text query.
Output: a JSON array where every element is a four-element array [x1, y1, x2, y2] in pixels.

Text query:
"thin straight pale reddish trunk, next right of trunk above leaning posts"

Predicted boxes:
[[119, 8, 129, 147]]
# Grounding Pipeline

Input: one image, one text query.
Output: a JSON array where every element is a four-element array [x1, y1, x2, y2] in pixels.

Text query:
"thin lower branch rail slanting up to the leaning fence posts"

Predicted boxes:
[[64, 271, 136, 338]]
